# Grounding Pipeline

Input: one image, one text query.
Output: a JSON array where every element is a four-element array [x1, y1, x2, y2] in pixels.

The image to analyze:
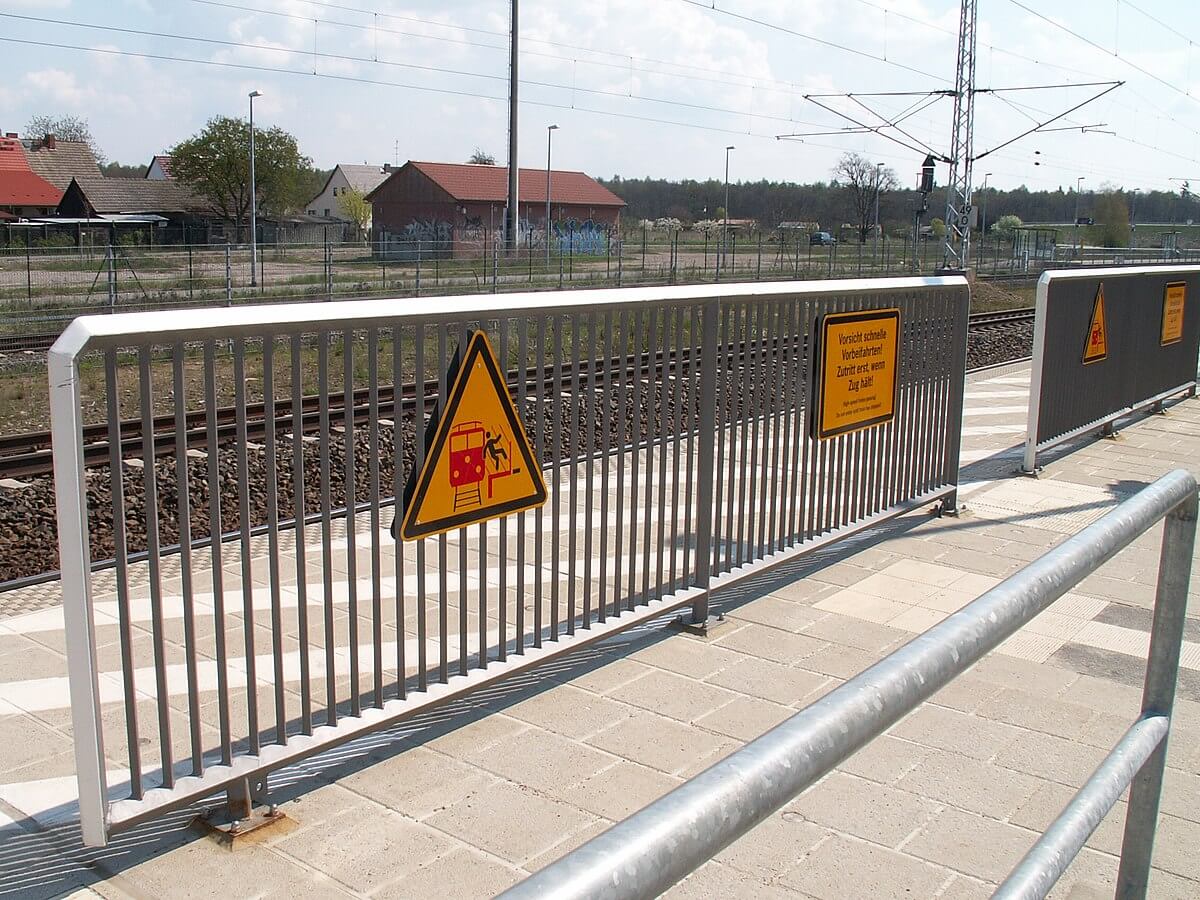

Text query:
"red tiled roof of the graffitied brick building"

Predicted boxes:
[[408, 162, 625, 206]]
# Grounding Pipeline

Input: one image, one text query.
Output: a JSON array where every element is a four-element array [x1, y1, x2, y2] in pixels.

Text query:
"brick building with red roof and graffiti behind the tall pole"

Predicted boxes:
[[367, 161, 625, 257]]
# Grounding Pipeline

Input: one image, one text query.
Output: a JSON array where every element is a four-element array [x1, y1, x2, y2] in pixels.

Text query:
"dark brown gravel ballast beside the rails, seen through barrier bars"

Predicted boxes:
[[0, 325, 1033, 581]]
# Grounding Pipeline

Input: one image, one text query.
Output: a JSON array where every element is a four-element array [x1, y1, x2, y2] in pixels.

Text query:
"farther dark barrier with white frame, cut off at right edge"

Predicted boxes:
[[1022, 265, 1200, 473]]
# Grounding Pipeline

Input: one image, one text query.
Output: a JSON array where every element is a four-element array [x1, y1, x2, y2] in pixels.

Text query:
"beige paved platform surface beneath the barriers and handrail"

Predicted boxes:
[[0, 366, 1200, 900]]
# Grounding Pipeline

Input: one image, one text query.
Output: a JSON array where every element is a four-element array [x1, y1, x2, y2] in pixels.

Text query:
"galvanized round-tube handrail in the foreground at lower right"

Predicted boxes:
[[502, 470, 1196, 900]]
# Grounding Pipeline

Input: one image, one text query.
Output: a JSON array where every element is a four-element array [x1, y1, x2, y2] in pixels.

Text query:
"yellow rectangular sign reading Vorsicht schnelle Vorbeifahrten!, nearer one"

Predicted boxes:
[[814, 308, 900, 440]]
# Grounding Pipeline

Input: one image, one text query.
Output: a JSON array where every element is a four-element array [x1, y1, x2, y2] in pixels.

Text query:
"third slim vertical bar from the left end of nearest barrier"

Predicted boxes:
[[169, 342, 204, 775]]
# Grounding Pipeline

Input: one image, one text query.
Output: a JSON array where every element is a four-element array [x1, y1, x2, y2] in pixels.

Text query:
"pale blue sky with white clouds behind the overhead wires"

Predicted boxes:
[[0, 0, 1200, 191]]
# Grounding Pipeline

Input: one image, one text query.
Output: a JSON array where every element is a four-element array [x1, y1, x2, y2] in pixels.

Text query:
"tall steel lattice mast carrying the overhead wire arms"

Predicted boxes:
[[942, 0, 979, 271]]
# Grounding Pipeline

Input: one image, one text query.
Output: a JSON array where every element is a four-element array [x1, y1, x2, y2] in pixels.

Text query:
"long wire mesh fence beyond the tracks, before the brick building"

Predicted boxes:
[[0, 229, 1200, 334]]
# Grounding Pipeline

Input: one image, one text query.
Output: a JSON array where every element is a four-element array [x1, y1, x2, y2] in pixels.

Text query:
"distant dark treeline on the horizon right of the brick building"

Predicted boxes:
[[600, 176, 1200, 232]]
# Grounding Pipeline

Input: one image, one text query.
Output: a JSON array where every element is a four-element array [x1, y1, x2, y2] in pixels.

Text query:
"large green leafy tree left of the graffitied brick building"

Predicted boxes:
[[168, 115, 312, 241]]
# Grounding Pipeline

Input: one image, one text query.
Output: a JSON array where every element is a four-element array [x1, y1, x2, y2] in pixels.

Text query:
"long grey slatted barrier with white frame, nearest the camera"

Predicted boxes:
[[49, 277, 968, 845]]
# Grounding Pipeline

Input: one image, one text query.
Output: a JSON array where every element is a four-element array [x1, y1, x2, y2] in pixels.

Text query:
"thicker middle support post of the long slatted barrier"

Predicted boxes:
[[690, 296, 720, 629]]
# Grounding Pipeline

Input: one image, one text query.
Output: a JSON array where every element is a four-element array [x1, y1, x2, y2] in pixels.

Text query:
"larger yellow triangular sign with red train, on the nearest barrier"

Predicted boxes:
[[401, 331, 546, 540]]
